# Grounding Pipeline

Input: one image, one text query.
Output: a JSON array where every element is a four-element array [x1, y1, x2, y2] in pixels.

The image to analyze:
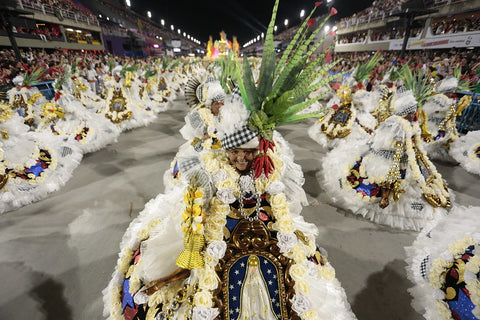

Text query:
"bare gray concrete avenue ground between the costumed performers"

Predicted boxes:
[[0, 100, 480, 320]]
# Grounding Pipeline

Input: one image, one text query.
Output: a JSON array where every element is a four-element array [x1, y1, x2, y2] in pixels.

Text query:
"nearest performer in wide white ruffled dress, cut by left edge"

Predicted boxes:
[[0, 104, 82, 213]]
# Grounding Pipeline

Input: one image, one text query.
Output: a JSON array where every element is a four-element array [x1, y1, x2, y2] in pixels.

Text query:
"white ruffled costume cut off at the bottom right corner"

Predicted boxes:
[[405, 206, 480, 320]]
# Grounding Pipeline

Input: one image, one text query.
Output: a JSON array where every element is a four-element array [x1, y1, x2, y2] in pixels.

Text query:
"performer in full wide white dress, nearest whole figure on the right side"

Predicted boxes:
[[321, 90, 451, 231]]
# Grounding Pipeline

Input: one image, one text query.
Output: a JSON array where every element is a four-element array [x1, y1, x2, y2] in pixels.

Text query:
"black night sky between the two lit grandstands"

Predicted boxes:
[[122, 0, 373, 44]]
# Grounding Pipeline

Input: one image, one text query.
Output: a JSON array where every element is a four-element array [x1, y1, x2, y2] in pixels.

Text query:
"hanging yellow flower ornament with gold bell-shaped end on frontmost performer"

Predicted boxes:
[[176, 183, 205, 270]]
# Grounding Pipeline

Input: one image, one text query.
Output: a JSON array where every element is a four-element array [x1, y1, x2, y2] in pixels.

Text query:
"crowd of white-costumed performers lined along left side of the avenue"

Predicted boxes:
[[0, 58, 207, 212]]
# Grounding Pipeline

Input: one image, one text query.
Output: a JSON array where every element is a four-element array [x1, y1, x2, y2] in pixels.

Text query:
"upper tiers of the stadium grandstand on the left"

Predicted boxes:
[[0, 0, 202, 56]]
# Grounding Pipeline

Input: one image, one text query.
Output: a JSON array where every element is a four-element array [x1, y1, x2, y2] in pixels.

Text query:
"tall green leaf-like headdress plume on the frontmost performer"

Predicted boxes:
[[235, 0, 339, 141]]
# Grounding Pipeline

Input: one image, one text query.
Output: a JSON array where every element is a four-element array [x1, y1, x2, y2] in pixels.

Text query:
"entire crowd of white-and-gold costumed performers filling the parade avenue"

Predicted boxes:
[[0, 5, 480, 320]]
